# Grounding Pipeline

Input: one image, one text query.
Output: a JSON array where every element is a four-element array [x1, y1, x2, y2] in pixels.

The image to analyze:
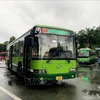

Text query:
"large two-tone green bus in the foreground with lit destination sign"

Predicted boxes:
[[6, 25, 76, 81]]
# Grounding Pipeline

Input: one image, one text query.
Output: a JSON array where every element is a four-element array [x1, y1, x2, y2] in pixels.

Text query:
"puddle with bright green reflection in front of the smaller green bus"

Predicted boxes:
[[77, 64, 100, 85]]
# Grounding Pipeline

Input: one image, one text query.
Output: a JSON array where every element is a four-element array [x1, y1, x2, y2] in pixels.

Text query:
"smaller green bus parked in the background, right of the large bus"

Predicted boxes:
[[78, 48, 97, 64]]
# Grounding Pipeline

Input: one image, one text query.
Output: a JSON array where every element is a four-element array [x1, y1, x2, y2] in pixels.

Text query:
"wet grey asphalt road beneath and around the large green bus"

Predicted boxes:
[[0, 62, 100, 100]]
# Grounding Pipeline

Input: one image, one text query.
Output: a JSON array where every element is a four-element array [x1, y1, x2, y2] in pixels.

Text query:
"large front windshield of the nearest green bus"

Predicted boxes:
[[38, 34, 75, 59]]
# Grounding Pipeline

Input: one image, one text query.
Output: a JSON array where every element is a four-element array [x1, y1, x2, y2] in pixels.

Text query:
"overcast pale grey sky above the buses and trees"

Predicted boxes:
[[0, 0, 100, 43]]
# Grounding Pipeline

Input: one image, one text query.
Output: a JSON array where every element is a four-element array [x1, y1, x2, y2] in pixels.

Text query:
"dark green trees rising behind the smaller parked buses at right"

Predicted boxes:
[[78, 26, 100, 49]]
